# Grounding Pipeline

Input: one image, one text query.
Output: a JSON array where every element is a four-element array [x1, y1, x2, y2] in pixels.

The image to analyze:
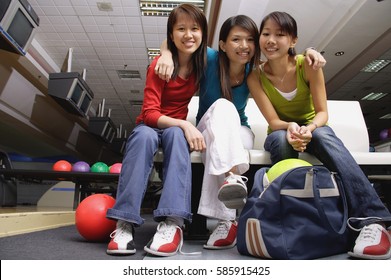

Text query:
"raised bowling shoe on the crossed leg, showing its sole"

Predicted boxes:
[[217, 172, 248, 209]]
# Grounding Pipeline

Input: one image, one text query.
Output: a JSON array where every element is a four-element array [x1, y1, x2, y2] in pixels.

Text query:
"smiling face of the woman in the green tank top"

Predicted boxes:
[[259, 18, 297, 60]]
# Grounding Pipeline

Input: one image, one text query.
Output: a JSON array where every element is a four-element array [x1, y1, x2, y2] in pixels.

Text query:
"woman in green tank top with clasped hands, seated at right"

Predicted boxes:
[[247, 12, 391, 259]]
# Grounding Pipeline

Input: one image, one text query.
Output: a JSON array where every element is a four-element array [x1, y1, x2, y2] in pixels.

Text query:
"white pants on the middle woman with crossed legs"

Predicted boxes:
[[197, 98, 254, 220]]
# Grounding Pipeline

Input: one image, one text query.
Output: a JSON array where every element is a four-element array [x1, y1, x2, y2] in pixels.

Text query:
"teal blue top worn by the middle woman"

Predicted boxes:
[[197, 48, 250, 126]]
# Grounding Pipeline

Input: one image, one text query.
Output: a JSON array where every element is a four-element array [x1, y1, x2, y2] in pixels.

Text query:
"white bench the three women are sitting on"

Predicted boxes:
[[183, 96, 391, 170]]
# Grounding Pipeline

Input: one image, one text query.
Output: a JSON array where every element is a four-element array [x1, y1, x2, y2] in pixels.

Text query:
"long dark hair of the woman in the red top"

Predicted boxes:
[[167, 4, 208, 83]]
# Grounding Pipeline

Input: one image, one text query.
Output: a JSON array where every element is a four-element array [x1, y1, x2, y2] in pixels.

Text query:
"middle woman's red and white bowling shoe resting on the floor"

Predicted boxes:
[[204, 221, 238, 250]]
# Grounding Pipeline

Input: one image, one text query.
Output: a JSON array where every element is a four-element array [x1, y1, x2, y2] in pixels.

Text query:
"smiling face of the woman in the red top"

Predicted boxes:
[[171, 13, 202, 55]]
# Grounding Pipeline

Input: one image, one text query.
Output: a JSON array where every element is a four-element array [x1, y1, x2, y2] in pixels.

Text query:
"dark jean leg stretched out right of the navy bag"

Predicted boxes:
[[307, 126, 391, 226]]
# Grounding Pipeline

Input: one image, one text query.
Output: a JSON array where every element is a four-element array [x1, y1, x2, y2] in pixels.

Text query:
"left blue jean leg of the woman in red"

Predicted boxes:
[[107, 124, 159, 225]]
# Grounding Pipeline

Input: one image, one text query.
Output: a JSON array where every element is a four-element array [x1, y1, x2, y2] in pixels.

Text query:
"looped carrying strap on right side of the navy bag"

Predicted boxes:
[[309, 169, 348, 234]]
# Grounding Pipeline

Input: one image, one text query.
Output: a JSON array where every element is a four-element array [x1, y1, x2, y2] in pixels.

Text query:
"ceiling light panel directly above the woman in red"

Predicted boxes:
[[140, 0, 205, 17]]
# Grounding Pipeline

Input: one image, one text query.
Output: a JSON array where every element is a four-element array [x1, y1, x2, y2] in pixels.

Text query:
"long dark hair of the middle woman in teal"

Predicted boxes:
[[219, 15, 260, 101]]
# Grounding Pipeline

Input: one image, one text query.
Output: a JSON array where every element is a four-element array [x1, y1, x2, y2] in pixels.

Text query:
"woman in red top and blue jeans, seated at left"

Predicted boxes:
[[107, 4, 207, 256]]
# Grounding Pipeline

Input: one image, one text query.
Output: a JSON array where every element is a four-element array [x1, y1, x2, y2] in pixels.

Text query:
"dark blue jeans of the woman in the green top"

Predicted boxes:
[[264, 126, 391, 227]]
